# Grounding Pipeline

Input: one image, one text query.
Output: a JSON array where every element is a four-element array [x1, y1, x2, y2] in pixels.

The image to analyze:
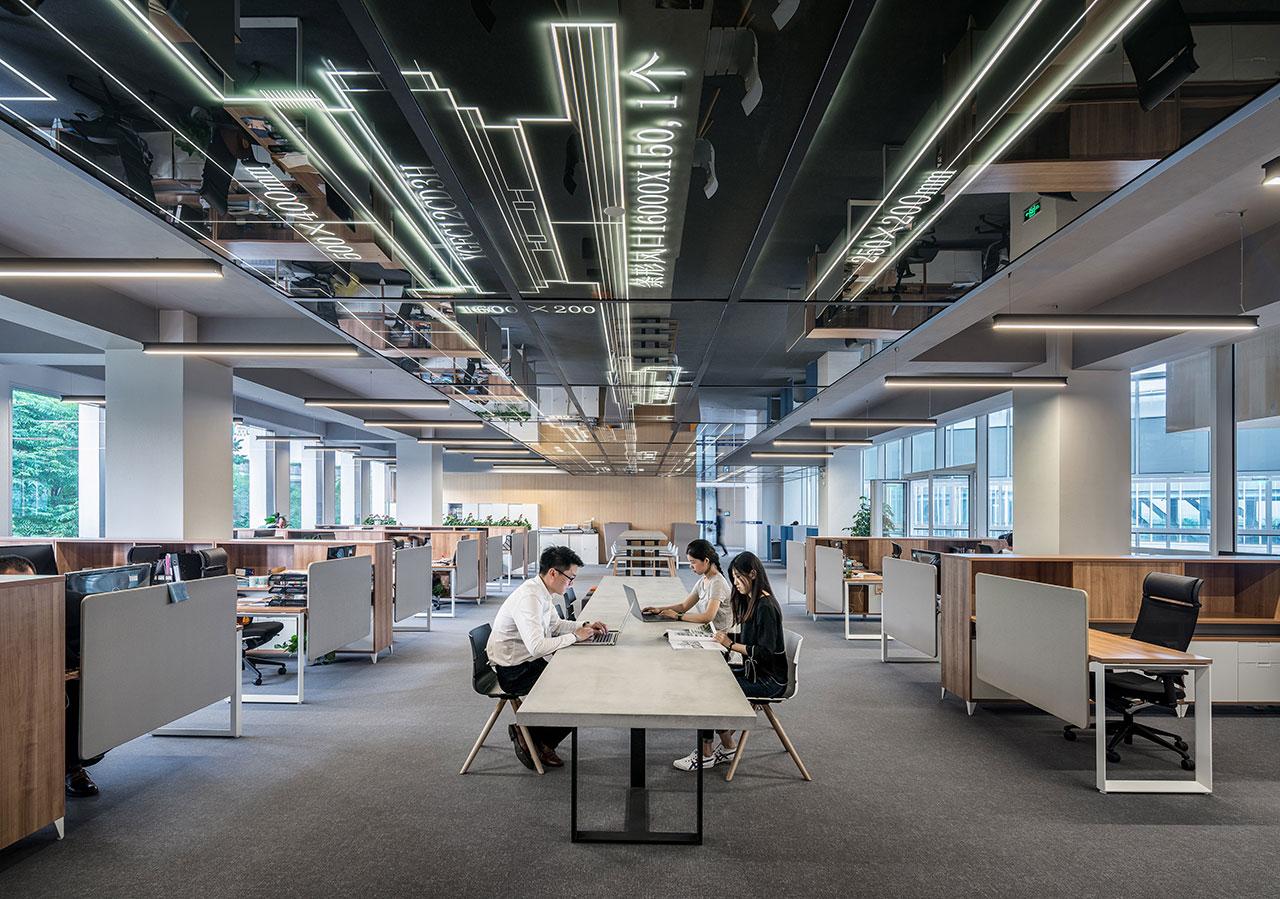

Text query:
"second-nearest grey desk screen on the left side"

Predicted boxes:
[[307, 556, 374, 662]]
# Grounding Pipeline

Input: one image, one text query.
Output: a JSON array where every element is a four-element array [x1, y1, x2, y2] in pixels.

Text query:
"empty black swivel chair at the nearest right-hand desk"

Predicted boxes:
[[1062, 571, 1208, 771]]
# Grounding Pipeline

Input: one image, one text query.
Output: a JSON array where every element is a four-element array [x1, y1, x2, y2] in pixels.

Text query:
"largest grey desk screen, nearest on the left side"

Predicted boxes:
[[79, 576, 238, 758]]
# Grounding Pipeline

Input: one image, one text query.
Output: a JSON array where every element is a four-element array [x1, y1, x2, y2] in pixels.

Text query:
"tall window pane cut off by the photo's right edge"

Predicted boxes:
[[1234, 330, 1280, 555]]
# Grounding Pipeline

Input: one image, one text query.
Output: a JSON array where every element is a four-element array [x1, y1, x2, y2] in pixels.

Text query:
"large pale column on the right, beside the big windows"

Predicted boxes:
[[1014, 371, 1132, 555]]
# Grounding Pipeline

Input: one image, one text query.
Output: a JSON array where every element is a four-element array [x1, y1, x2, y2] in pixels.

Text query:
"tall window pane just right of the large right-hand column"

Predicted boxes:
[[1130, 363, 1212, 552]]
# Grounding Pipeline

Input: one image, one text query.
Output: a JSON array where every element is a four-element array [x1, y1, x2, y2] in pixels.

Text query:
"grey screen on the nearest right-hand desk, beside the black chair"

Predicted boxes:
[[974, 574, 1089, 727]]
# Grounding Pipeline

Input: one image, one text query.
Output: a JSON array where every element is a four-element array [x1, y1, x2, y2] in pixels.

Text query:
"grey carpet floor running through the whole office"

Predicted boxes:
[[0, 570, 1280, 898]]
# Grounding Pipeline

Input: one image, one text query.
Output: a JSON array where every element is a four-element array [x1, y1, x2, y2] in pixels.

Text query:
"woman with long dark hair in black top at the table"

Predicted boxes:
[[716, 552, 787, 699]]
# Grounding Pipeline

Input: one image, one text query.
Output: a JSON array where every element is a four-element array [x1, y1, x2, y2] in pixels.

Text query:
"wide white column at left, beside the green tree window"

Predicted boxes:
[[106, 350, 232, 540]]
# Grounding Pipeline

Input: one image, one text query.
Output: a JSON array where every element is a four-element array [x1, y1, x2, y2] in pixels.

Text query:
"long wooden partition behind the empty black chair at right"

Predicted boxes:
[[942, 553, 1280, 702]]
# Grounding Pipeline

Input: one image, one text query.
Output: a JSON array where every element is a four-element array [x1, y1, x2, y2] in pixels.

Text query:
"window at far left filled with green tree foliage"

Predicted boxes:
[[12, 389, 81, 537]]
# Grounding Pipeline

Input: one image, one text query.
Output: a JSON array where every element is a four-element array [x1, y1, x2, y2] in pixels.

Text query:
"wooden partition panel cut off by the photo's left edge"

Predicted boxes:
[[0, 575, 65, 849]]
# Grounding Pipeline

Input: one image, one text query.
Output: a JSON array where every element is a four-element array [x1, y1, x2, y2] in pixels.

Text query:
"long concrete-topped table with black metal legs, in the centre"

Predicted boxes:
[[516, 575, 755, 845]]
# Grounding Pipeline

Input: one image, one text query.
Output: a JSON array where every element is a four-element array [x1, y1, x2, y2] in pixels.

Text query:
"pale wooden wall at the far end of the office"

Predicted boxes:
[[444, 471, 698, 548]]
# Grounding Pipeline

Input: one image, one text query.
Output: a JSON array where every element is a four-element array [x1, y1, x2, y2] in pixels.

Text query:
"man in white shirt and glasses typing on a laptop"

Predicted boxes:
[[485, 547, 608, 770]]
